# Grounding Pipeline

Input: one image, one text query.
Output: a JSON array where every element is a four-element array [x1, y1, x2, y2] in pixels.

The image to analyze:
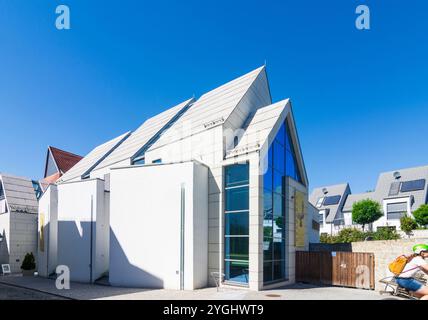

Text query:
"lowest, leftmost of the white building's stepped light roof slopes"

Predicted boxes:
[[58, 132, 130, 182]]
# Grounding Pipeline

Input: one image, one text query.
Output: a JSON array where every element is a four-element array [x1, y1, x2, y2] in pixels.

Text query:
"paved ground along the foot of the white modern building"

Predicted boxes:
[[0, 275, 391, 300]]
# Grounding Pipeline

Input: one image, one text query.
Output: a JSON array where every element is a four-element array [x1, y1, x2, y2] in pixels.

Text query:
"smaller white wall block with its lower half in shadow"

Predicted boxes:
[[58, 179, 108, 282]]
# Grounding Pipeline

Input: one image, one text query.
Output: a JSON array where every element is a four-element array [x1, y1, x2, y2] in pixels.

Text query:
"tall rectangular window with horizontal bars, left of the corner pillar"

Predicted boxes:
[[224, 164, 249, 284]]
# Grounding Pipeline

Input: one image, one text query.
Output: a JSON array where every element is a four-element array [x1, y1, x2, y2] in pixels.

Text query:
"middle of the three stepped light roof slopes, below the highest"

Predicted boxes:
[[94, 99, 194, 171]]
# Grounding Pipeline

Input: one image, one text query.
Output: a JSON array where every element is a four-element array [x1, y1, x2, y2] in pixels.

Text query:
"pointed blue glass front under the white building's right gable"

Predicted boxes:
[[263, 123, 302, 283]]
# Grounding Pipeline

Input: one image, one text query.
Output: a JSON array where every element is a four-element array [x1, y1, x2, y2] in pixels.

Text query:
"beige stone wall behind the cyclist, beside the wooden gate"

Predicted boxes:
[[352, 238, 428, 291]]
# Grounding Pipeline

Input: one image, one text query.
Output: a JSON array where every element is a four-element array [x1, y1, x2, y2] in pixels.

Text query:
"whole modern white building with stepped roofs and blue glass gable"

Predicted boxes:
[[38, 67, 318, 290]]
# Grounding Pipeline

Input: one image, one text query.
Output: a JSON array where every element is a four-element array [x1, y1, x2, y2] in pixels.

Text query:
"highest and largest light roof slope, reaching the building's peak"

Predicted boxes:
[[150, 66, 268, 150]]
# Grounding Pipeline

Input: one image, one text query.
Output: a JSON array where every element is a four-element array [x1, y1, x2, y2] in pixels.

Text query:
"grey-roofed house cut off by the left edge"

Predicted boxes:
[[0, 173, 42, 273]]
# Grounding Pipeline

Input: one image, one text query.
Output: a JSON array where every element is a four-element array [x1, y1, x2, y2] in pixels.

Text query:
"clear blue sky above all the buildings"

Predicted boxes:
[[0, 0, 428, 192]]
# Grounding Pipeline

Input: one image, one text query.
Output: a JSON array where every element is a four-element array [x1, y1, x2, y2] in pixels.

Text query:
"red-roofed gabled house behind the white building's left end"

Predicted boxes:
[[40, 146, 83, 190]]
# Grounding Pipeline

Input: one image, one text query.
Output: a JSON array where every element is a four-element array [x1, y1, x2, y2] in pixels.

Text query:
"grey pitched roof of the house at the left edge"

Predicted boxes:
[[0, 173, 38, 214]]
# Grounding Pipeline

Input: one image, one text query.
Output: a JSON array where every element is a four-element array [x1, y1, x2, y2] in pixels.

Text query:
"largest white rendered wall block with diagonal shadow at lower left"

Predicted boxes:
[[109, 162, 208, 290]]
